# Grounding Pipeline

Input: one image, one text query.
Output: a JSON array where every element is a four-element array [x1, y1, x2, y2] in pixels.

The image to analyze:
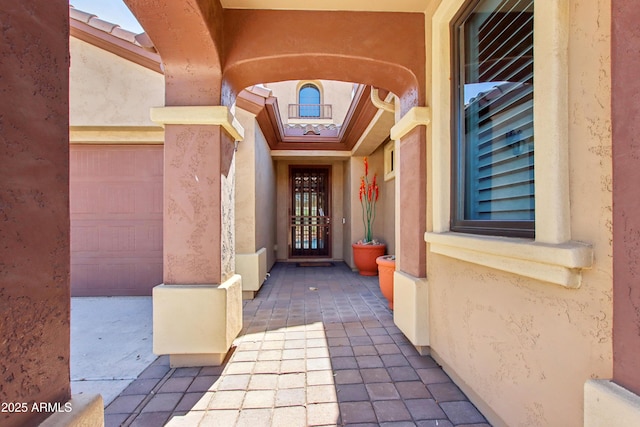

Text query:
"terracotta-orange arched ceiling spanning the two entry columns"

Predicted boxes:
[[125, 0, 424, 111]]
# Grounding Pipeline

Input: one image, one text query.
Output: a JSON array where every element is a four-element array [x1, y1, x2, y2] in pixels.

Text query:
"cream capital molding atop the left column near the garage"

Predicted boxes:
[[150, 105, 244, 141]]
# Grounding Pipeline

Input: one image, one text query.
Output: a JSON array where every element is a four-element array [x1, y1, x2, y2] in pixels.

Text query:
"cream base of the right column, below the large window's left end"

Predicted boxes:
[[393, 271, 430, 355]]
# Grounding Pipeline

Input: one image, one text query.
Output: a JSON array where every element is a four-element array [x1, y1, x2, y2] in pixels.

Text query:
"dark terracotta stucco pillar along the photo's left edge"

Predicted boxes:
[[0, 0, 70, 427]]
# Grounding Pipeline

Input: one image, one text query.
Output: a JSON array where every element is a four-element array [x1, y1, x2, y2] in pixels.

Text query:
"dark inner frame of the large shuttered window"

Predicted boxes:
[[449, 0, 536, 238]]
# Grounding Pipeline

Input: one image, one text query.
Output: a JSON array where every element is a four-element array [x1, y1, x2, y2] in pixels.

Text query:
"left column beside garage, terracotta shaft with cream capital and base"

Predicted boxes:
[[151, 106, 244, 366]]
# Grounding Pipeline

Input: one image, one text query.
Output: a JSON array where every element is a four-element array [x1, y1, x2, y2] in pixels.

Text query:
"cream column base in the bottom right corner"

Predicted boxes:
[[584, 380, 640, 427]]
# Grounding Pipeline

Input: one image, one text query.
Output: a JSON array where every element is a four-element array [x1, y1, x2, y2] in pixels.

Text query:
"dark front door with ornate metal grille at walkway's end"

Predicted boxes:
[[289, 166, 331, 258]]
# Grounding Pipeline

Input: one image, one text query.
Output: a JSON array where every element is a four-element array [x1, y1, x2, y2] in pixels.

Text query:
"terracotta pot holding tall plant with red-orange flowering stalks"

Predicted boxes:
[[351, 157, 386, 276]]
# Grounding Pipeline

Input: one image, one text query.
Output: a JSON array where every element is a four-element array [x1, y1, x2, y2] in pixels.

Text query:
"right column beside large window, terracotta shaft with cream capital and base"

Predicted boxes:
[[391, 107, 430, 353]]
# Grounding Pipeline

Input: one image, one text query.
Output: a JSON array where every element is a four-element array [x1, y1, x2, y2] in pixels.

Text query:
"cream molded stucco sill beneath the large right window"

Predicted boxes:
[[424, 232, 594, 289]]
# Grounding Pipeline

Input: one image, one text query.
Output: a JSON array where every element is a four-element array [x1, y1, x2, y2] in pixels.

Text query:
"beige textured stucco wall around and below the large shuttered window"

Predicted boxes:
[[427, 0, 612, 426]]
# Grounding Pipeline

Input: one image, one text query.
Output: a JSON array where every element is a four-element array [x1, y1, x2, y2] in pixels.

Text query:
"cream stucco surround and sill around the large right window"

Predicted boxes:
[[422, 0, 594, 288]]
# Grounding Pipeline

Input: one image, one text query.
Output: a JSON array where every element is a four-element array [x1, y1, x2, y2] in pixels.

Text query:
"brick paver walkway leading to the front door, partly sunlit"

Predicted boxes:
[[105, 264, 489, 427]]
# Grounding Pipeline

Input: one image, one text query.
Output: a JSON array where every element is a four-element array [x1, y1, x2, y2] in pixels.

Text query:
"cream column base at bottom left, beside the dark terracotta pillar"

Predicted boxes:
[[40, 394, 104, 427]]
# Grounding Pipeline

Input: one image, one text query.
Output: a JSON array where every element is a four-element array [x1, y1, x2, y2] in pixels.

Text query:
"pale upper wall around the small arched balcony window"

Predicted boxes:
[[265, 80, 353, 124]]
